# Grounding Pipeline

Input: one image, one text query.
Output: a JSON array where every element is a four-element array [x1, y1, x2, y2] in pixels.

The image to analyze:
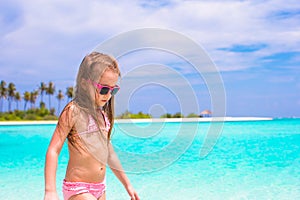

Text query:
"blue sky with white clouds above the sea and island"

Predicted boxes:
[[0, 0, 300, 117]]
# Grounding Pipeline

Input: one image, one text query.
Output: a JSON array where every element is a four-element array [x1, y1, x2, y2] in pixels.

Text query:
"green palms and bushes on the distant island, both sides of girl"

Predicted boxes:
[[0, 80, 211, 121]]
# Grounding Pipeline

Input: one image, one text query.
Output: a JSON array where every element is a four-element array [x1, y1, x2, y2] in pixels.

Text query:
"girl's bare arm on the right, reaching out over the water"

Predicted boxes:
[[108, 143, 140, 200]]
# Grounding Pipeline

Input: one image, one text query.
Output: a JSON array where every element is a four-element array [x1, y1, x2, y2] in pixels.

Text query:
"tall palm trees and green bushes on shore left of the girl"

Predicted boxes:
[[0, 80, 73, 121]]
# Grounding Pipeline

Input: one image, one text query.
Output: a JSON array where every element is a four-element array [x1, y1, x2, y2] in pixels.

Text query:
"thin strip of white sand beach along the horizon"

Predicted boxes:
[[0, 117, 273, 126]]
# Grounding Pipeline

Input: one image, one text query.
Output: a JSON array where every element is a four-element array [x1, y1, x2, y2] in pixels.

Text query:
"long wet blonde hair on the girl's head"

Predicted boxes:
[[73, 52, 121, 140]]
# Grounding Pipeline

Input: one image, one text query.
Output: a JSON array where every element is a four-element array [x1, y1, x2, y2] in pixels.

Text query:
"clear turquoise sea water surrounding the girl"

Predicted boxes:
[[0, 119, 300, 200]]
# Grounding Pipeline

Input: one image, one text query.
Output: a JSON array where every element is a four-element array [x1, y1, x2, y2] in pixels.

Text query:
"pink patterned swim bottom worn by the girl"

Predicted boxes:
[[63, 179, 106, 200]]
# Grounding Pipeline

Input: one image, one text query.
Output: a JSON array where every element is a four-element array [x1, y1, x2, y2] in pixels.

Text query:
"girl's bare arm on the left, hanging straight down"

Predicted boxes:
[[44, 104, 73, 200]]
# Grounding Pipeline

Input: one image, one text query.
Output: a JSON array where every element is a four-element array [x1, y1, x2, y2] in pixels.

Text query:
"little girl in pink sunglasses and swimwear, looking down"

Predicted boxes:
[[44, 52, 139, 200]]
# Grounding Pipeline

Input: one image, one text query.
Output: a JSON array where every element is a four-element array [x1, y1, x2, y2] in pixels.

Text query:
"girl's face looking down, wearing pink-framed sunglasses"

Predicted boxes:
[[95, 69, 119, 107]]
